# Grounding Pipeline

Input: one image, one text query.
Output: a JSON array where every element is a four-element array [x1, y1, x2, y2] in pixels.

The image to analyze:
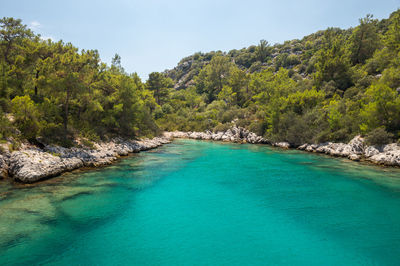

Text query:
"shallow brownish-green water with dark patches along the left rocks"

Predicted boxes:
[[0, 141, 203, 265]]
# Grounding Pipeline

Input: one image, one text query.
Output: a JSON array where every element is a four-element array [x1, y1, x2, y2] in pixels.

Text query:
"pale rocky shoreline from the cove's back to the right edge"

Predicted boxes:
[[164, 127, 400, 167]]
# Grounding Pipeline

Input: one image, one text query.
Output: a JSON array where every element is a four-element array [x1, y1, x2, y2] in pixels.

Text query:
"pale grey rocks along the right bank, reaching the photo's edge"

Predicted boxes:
[[297, 136, 400, 166]]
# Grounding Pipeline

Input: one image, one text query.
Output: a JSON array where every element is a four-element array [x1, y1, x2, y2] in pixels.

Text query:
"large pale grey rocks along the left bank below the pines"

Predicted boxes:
[[8, 137, 169, 183]]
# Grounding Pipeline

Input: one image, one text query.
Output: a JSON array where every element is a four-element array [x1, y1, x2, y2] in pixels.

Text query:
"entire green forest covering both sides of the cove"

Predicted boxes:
[[0, 10, 400, 146]]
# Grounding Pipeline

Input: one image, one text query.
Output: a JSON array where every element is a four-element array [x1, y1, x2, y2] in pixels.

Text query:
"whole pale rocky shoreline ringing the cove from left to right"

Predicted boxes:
[[0, 127, 400, 184]]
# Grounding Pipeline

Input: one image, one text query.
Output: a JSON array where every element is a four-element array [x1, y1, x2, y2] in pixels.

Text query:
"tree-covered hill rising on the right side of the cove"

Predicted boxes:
[[154, 10, 400, 145]]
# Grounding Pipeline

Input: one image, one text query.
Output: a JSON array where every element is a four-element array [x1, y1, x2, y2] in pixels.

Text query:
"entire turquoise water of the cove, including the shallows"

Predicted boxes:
[[0, 140, 400, 265]]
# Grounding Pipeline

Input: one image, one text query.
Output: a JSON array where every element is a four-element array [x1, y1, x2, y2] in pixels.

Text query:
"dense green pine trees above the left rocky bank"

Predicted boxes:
[[0, 18, 159, 145]]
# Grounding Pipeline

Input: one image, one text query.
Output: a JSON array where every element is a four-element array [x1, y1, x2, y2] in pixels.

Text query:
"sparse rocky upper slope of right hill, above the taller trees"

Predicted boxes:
[[164, 12, 390, 89]]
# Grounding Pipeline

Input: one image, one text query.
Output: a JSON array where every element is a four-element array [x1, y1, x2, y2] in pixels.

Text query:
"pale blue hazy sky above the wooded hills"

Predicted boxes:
[[0, 0, 400, 80]]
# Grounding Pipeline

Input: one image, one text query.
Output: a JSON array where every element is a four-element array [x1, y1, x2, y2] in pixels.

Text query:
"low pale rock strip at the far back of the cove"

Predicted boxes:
[[164, 126, 270, 144]]
